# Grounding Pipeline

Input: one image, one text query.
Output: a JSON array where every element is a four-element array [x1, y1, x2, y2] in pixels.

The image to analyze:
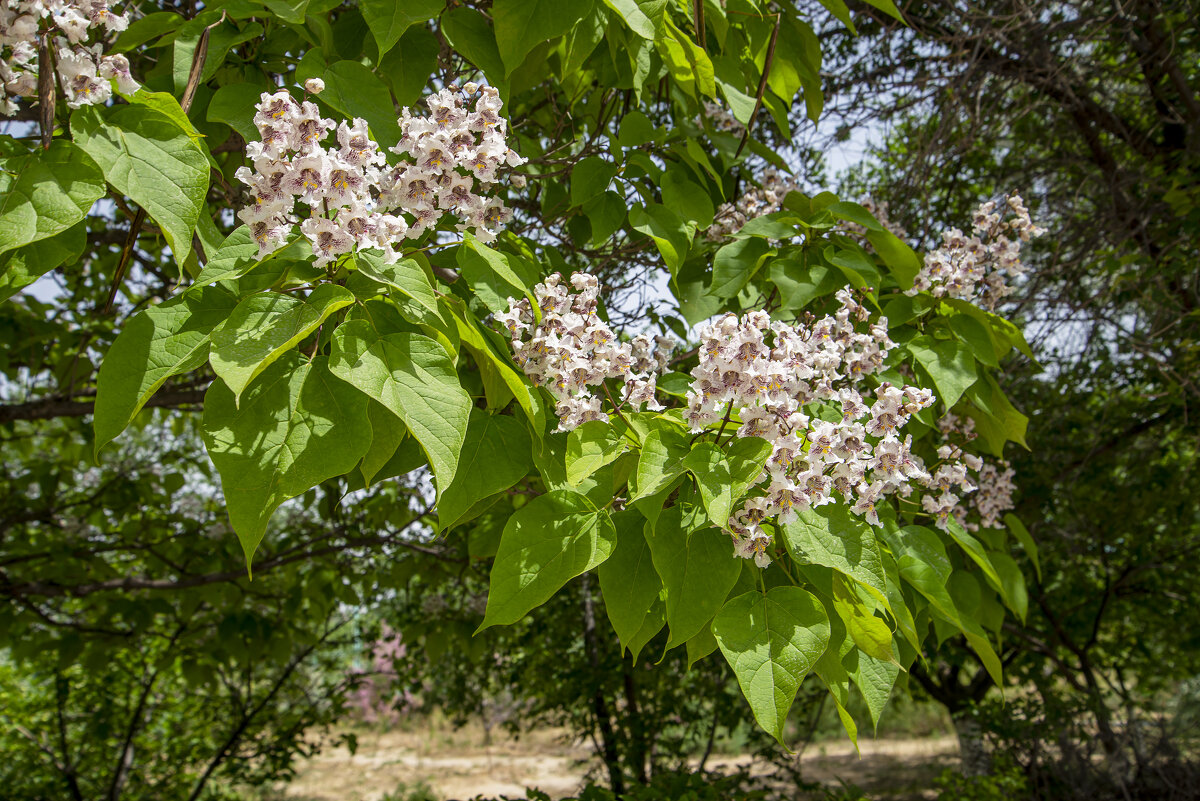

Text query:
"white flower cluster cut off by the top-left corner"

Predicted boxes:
[[0, 0, 139, 116]]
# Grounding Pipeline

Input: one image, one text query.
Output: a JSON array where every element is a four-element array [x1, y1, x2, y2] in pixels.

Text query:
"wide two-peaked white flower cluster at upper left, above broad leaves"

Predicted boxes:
[[238, 82, 524, 266]]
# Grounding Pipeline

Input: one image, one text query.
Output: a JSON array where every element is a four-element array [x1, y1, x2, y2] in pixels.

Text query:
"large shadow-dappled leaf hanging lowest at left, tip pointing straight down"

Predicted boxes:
[[203, 353, 371, 565]]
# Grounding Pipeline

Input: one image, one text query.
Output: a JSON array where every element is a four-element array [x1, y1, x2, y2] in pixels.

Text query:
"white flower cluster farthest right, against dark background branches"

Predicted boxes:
[[905, 194, 1045, 309]]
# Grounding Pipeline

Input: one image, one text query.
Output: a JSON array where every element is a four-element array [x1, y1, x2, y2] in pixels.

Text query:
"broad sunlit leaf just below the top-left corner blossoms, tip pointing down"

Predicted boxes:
[[71, 106, 209, 266]]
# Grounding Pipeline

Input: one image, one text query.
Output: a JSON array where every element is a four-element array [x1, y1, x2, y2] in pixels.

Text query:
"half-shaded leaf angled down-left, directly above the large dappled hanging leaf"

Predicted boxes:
[[209, 284, 354, 403]]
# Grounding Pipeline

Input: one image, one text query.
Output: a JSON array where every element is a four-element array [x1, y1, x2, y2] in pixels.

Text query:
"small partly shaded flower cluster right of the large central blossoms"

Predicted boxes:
[[922, 412, 1016, 531]]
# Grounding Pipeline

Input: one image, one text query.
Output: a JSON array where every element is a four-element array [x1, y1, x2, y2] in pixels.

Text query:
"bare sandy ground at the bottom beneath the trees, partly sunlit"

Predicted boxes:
[[281, 727, 958, 801]]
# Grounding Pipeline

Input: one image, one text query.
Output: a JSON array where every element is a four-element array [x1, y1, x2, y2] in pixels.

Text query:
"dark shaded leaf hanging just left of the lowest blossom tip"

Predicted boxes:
[[646, 505, 742, 649]]
